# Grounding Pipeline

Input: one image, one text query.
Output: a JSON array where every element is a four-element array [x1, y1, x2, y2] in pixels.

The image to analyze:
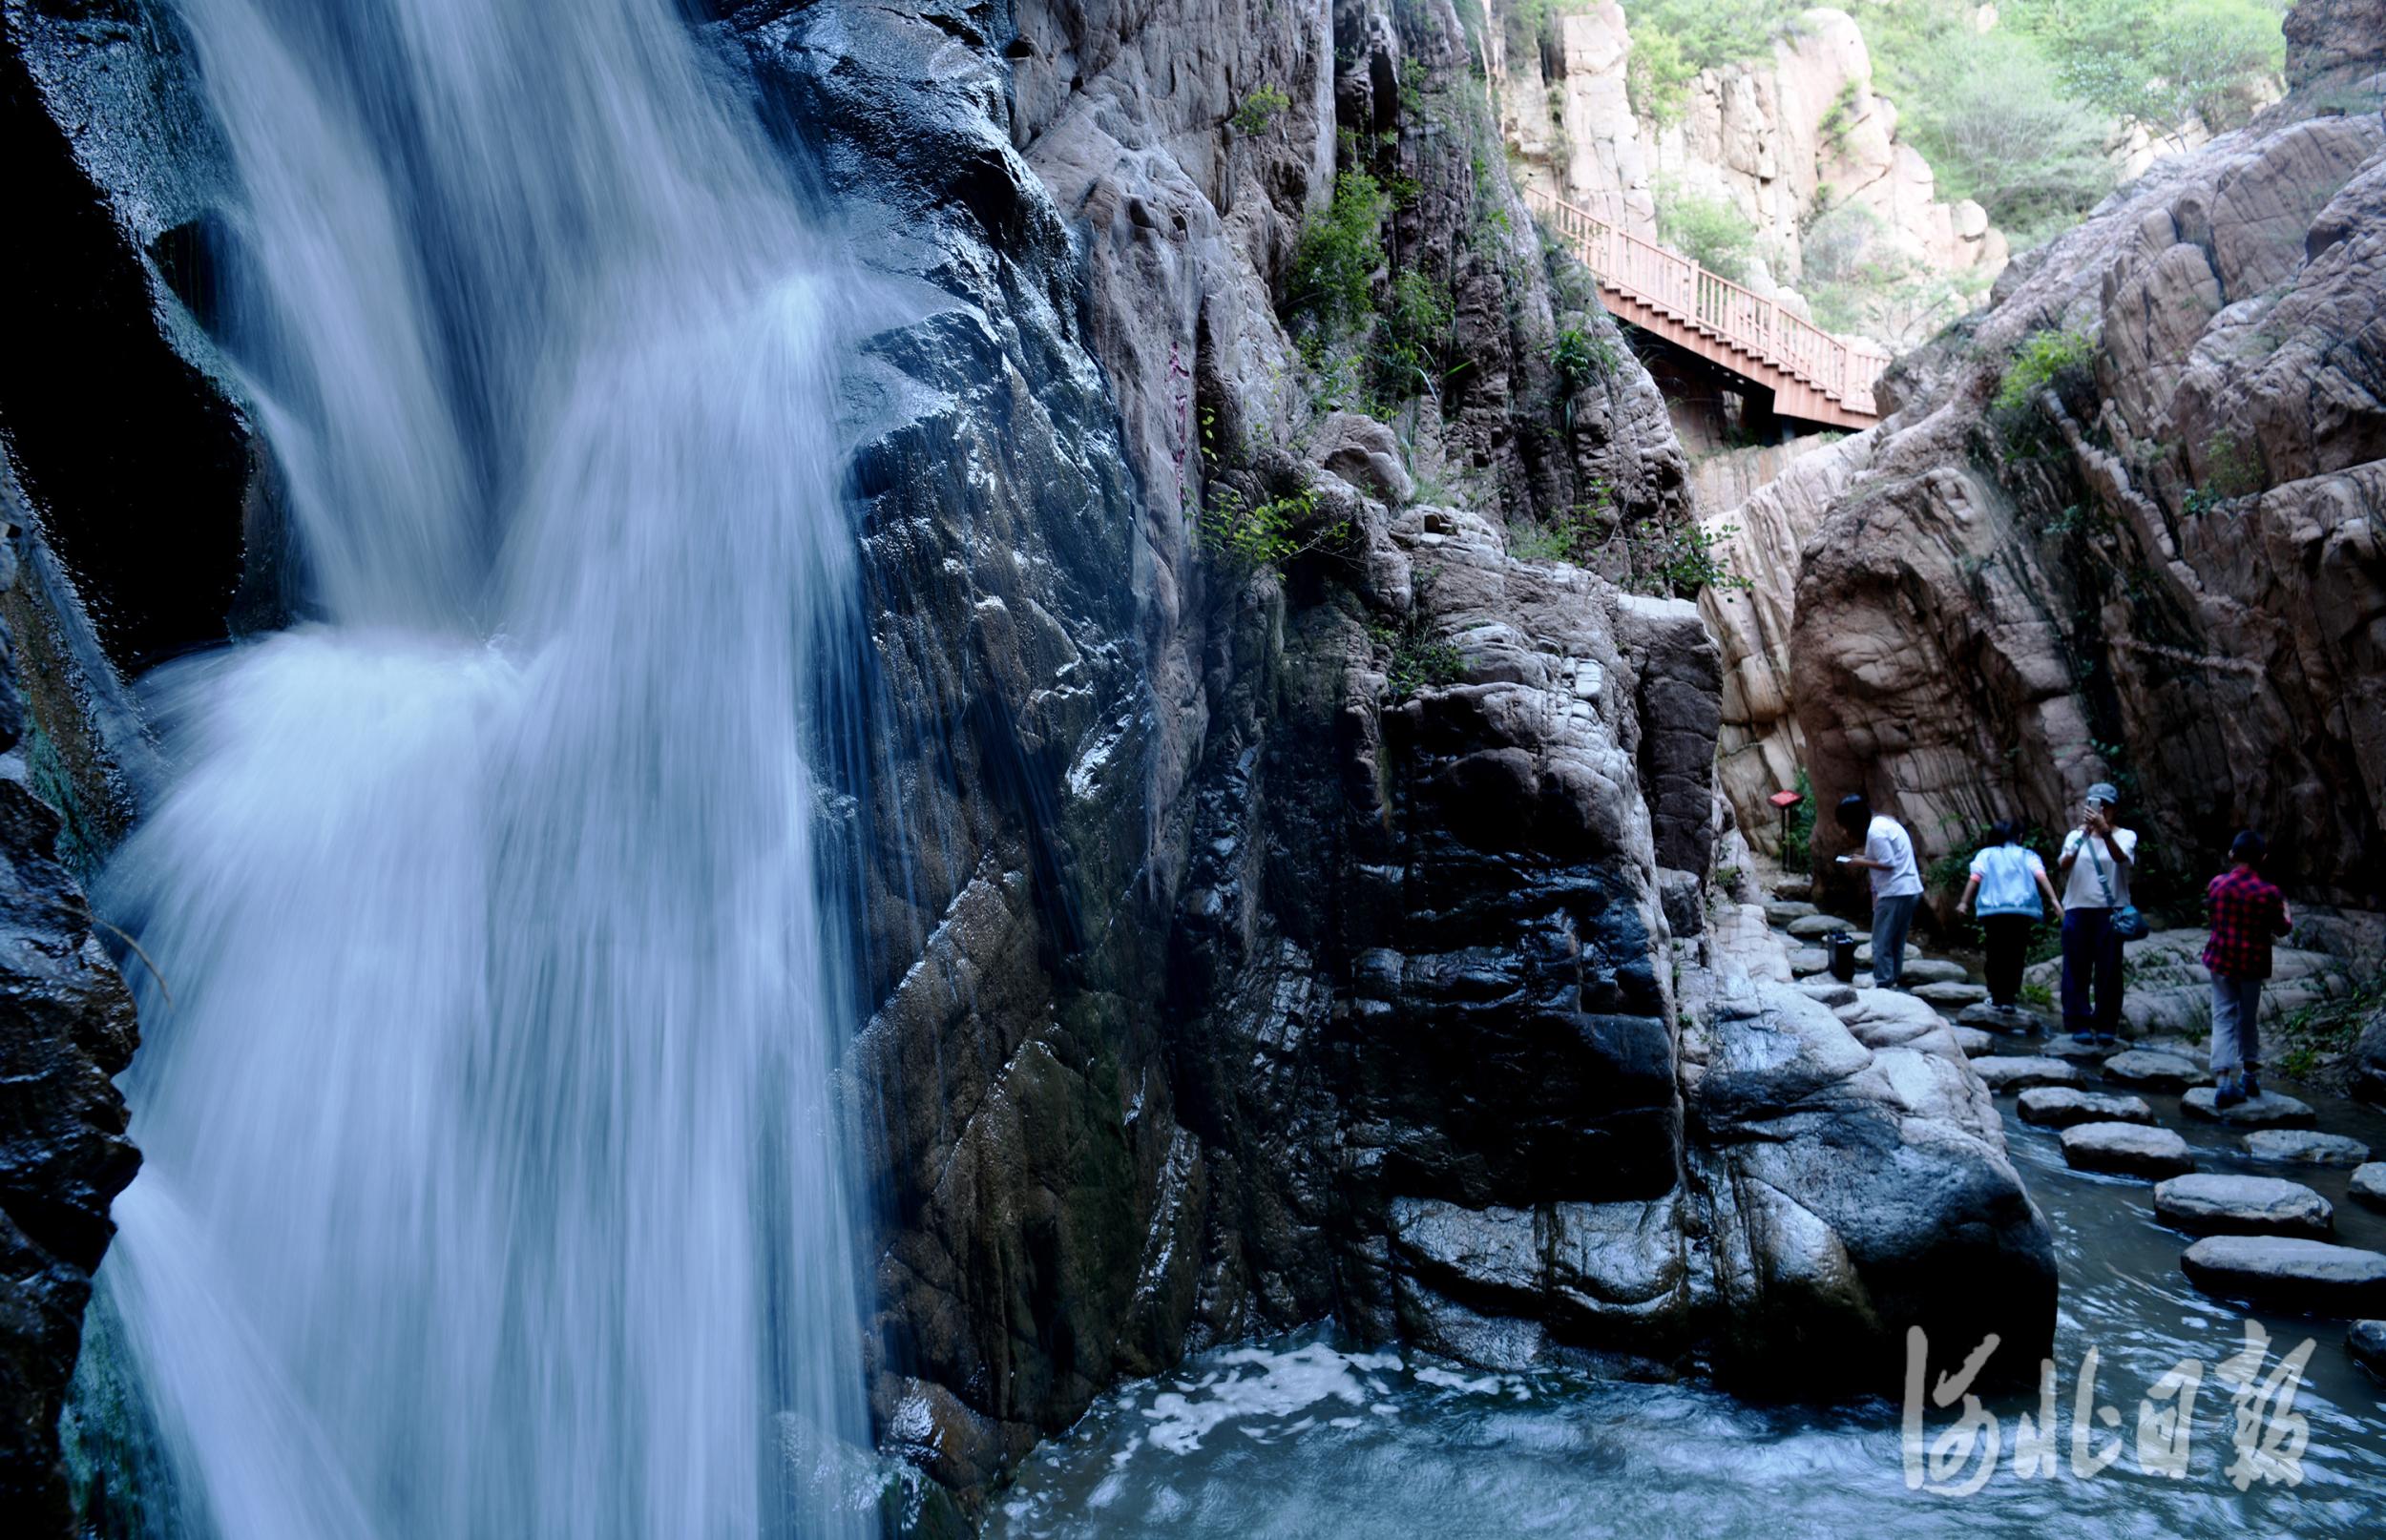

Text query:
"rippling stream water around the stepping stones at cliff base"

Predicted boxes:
[[988, 1087, 2386, 1540]]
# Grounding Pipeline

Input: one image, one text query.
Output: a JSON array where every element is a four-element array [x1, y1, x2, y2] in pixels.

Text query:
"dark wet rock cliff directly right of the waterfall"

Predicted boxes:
[[12, 0, 2052, 1526]]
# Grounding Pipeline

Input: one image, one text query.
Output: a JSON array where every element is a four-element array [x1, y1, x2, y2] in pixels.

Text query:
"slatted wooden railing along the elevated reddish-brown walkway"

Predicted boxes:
[[1525, 188, 1890, 417]]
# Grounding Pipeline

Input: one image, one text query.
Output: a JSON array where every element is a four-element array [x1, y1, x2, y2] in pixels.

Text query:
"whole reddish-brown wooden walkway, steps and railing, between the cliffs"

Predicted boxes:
[[1525, 191, 1890, 429]]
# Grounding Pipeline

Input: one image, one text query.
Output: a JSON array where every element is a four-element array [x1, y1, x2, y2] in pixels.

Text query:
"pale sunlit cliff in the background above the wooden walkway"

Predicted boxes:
[[1494, 0, 2007, 328]]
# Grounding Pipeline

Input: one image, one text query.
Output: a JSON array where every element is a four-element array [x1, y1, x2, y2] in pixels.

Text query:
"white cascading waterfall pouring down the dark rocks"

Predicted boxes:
[[103, 0, 883, 1540]]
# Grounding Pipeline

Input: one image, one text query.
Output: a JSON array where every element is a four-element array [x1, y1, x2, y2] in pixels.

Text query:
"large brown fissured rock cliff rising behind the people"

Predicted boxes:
[[1785, 0, 2386, 908]]
